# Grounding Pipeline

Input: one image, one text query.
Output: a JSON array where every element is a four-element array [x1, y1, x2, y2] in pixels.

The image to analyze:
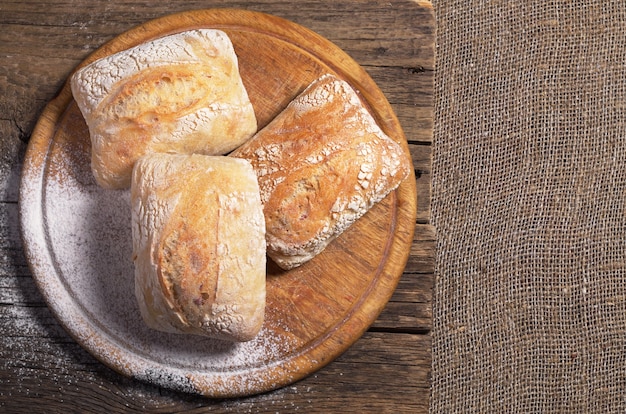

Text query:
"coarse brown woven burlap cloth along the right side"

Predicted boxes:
[[430, 0, 626, 413]]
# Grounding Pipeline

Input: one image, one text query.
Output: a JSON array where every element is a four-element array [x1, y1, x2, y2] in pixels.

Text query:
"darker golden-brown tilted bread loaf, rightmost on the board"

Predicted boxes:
[[231, 75, 412, 269]]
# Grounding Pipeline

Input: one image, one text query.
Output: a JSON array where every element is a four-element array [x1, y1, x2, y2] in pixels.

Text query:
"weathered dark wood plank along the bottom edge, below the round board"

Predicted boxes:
[[0, 333, 430, 413]]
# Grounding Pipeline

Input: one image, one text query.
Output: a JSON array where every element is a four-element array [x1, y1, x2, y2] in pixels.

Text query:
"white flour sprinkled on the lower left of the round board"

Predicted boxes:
[[34, 136, 297, 391]]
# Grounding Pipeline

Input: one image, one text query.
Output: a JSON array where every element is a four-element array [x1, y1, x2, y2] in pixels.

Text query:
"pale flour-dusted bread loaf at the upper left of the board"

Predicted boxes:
[[71, 29, 257, 189]]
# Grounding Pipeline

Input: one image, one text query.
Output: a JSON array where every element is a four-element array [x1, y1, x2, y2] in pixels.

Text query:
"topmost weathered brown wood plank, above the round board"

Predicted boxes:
[[0, 0, 434, 153]]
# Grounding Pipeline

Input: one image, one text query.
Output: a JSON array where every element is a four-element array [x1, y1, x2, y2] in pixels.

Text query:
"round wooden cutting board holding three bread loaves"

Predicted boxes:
[[20, 9, 416, 397]]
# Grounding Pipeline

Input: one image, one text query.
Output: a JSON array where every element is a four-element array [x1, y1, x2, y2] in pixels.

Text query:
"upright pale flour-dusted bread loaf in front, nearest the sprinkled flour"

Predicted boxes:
[[131, 154, 266, 341]]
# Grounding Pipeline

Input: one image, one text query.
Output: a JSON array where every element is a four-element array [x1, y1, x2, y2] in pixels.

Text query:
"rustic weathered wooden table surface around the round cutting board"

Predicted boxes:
[[0, 0, 435, 413]]
